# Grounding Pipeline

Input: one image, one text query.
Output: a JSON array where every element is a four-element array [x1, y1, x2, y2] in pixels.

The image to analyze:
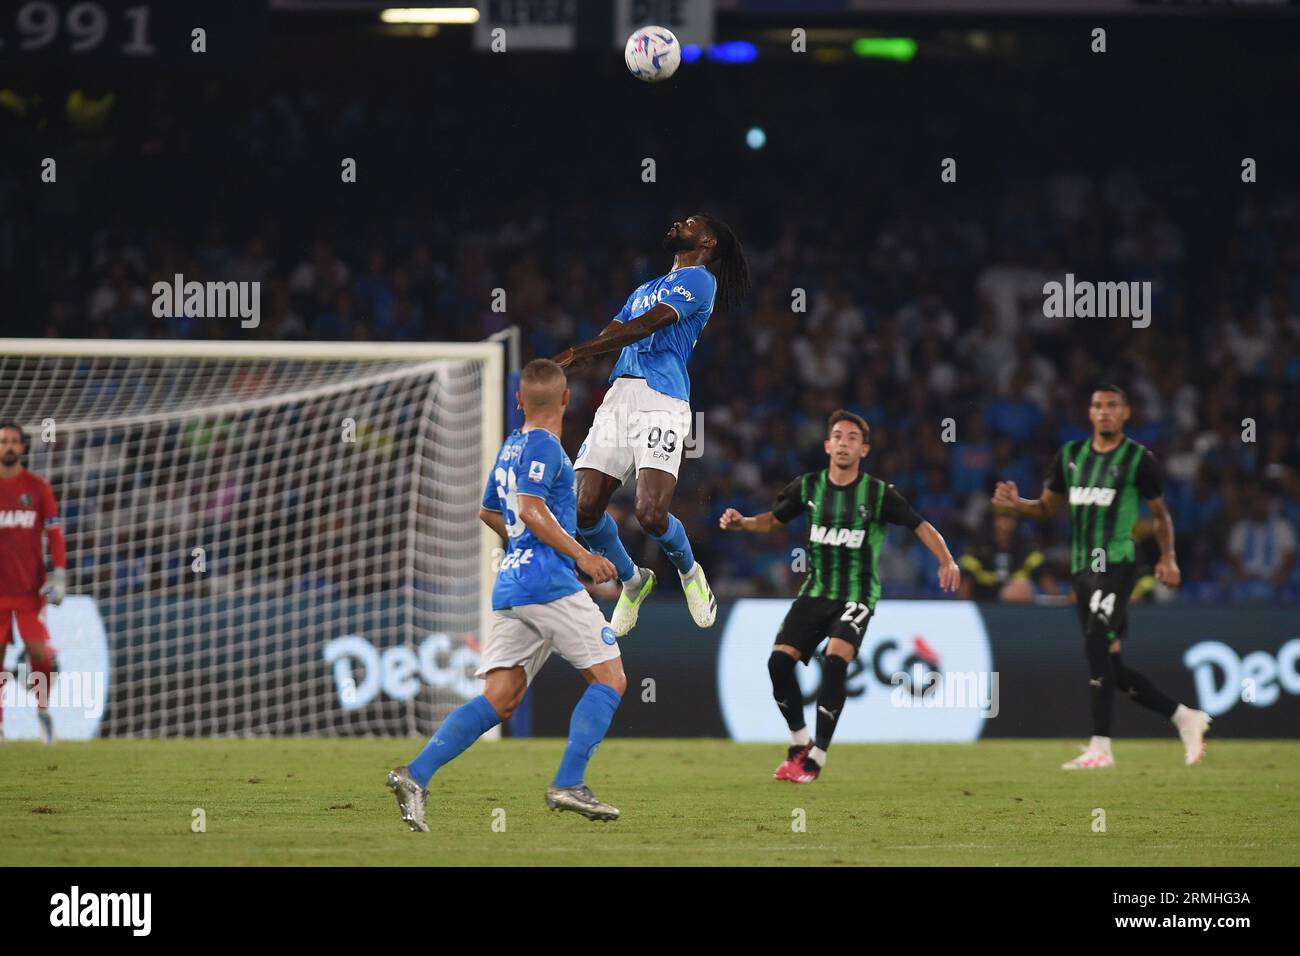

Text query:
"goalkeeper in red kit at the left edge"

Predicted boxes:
[[0, 421, 68, 744]]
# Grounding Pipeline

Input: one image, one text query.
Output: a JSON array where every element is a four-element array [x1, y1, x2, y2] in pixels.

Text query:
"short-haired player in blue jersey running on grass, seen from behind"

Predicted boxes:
[[387, 359, 628, 832]]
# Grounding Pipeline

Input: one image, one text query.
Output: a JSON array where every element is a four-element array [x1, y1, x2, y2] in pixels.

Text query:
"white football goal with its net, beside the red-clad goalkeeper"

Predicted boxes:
[[0, 339, 504, 736]]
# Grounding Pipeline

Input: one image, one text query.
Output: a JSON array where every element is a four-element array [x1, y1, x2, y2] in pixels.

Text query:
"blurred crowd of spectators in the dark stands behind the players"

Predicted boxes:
[[0, 54, 1300, 601]]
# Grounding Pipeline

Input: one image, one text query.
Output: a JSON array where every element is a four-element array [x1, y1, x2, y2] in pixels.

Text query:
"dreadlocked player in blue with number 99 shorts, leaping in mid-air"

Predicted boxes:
[[555, 215, 749, 637]]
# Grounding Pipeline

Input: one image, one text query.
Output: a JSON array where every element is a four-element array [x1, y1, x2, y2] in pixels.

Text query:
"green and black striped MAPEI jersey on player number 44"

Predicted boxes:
[[1044, 438, 1162, 574]]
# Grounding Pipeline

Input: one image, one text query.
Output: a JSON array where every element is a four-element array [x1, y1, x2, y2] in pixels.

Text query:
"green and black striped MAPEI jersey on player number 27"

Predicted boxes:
[[772, 470, 922, 607]]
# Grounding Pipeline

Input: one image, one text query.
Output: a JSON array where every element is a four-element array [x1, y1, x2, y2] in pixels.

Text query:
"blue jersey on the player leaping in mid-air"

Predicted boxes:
[[610, 265, 718, 402]]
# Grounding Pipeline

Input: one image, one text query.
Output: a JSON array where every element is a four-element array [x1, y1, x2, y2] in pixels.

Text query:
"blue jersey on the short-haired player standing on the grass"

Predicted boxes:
[[482, 428, 582, 611]]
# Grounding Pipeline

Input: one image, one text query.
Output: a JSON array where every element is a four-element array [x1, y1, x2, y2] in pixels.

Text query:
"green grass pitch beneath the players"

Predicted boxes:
[[0, 737, 1300, 866]]
